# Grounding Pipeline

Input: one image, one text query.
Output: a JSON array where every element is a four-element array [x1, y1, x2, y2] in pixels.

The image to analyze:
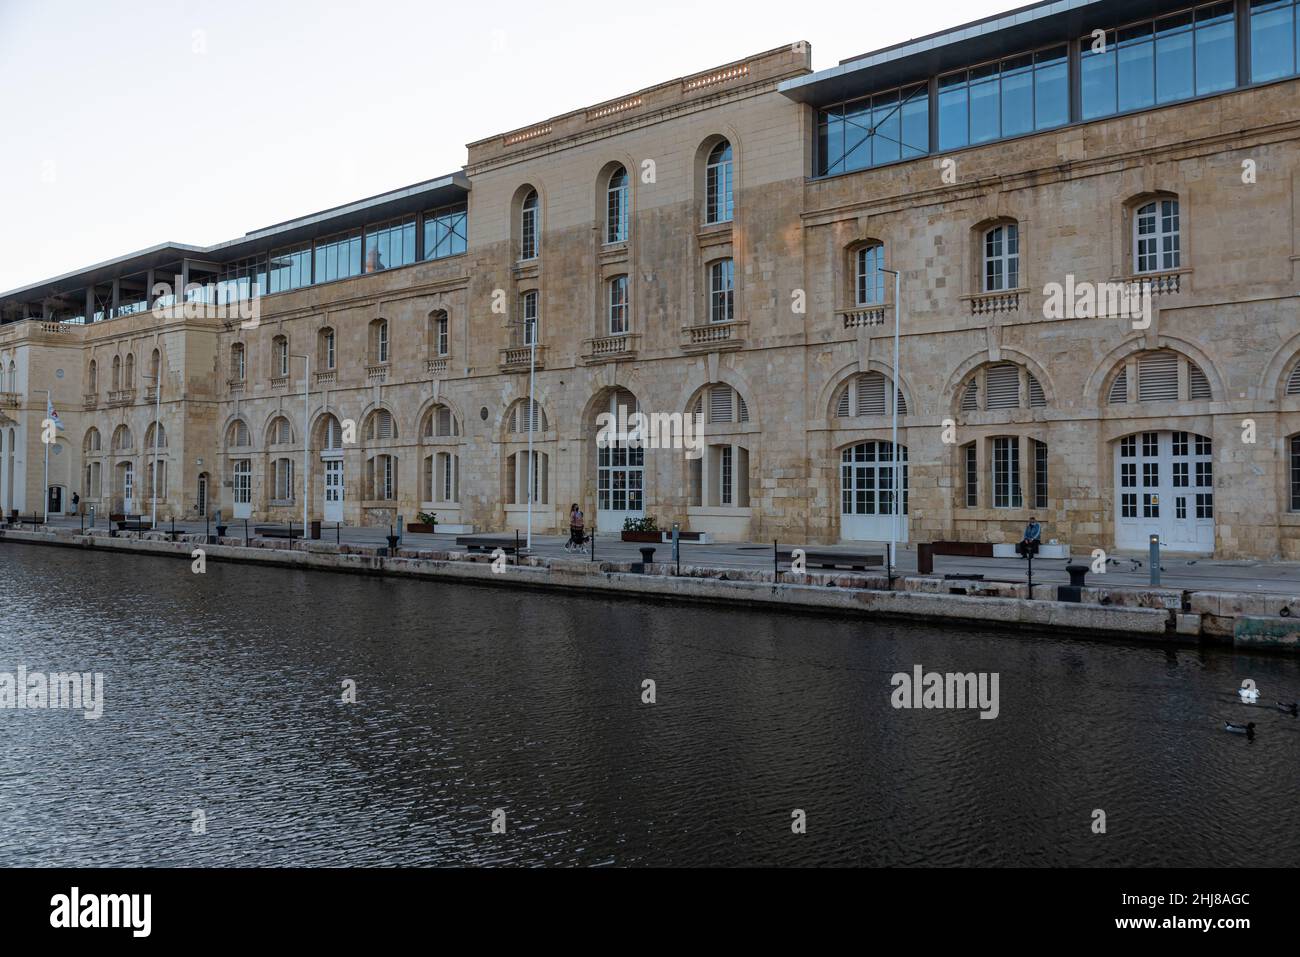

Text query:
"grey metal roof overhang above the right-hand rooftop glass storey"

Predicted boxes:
[[777, 0, 1196, 107]]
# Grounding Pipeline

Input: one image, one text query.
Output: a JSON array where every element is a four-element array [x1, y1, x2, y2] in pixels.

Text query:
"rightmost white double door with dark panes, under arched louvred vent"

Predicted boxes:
[[1115, 432, 1214, 554]]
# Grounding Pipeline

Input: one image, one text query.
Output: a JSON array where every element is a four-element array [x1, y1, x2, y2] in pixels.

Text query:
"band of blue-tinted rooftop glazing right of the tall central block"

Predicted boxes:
[[816, 0, 1300, 176]]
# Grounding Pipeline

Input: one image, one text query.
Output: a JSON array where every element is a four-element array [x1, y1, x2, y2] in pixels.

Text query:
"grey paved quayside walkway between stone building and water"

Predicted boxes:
[[22, 518, 1300, 596]]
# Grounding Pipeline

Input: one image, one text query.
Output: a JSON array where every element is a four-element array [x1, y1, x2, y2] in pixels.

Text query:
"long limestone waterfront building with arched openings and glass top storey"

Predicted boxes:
[[0, 0, 1300, 559]]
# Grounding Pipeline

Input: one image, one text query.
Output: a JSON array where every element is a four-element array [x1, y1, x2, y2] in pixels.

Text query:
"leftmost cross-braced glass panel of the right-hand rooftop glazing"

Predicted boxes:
[[818, 85, 930, 176]]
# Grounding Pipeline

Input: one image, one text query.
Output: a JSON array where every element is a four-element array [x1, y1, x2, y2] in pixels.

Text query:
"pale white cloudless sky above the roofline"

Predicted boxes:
[[0, 0, 1008, 291]]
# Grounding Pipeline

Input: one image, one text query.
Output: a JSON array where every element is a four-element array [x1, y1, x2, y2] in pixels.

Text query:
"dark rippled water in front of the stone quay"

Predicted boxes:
[[0, 545, 1300, 866]]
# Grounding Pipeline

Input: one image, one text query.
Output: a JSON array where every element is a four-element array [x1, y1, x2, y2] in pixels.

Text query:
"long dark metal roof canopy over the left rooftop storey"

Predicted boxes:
[[0, 172, 469, 304]]
